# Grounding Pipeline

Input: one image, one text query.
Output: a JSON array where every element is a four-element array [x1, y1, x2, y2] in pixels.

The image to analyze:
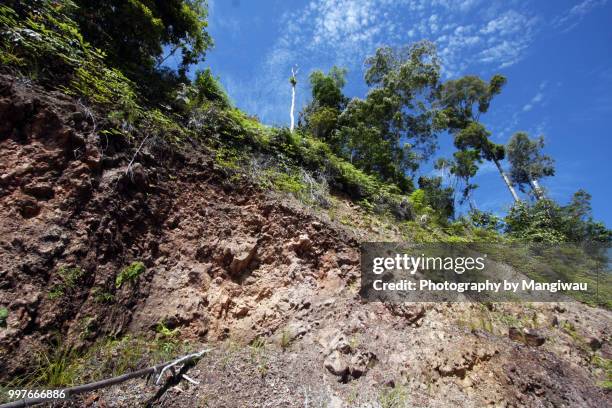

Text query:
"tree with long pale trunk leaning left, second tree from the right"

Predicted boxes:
[[439, 75, 520, 202]]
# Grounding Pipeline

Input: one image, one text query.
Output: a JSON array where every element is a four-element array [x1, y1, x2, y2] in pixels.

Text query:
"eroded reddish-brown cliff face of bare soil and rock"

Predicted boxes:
[[0, 76, 612, 407]]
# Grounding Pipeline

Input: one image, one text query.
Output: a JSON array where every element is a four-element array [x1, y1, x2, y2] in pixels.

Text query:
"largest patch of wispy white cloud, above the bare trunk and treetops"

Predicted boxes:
[[222, 0, 537, 123]]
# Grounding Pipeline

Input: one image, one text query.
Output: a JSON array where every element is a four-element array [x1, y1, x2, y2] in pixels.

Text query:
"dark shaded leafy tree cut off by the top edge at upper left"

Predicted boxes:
[[75, 0, 212, 83]]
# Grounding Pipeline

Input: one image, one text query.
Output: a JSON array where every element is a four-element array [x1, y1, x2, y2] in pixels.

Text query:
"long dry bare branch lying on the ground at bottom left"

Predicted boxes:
[[0, 349, 212, 408]]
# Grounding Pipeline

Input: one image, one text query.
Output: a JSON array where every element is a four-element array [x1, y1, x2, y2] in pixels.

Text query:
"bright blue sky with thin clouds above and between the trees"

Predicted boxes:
[[189, 0, 612, 227]]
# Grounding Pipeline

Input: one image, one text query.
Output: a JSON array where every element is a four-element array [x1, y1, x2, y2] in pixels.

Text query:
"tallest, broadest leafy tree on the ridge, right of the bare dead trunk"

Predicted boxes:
[[338, 42, 440, 189]]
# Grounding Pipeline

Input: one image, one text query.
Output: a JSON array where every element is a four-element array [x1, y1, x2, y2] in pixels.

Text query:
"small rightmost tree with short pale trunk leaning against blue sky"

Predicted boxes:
[[506, 132, 555, 200]]
